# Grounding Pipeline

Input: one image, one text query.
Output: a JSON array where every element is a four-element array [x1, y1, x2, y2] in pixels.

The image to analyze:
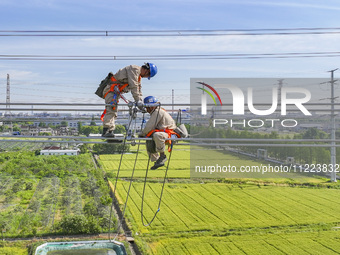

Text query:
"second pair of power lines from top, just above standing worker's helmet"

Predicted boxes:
[[0, 51, 340, 61]]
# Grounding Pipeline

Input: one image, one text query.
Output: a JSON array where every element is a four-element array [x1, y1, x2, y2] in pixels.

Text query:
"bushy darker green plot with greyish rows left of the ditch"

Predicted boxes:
[[0, 153, 111, 237]]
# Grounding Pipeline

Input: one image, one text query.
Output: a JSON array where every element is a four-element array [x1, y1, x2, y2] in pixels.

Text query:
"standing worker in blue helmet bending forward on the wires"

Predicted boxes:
[[95, 63, 157, 137]]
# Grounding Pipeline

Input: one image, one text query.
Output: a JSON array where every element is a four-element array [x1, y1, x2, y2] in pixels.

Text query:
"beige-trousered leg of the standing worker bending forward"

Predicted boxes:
[[103, 92, 118, 137]]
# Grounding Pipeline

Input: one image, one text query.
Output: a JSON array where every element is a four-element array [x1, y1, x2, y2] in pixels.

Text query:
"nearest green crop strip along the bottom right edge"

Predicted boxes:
[[148, 231, 340, 255]]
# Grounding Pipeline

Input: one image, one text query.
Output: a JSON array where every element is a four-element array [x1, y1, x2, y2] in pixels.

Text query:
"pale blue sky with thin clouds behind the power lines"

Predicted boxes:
[[0, 0, 340, 103]]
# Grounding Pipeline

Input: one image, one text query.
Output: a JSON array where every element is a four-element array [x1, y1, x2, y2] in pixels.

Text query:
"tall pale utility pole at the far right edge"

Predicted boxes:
[[329, 68, 338, 182]]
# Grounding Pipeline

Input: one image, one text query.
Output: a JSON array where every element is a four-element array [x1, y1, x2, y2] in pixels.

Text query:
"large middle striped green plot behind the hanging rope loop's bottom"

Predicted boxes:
[[114, 182, 340, 234]]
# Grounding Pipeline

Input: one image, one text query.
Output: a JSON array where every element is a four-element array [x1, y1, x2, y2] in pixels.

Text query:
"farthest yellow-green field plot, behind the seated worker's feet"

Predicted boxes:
[[100, 148, 314, 179]]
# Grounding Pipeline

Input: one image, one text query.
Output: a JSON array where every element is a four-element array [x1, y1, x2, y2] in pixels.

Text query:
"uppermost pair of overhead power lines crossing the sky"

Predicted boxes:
[[0, 27, 340, 37]]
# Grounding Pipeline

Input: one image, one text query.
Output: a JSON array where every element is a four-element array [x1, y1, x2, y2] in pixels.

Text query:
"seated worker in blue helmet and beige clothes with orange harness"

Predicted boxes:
[[139, 96, 176, 170]]
